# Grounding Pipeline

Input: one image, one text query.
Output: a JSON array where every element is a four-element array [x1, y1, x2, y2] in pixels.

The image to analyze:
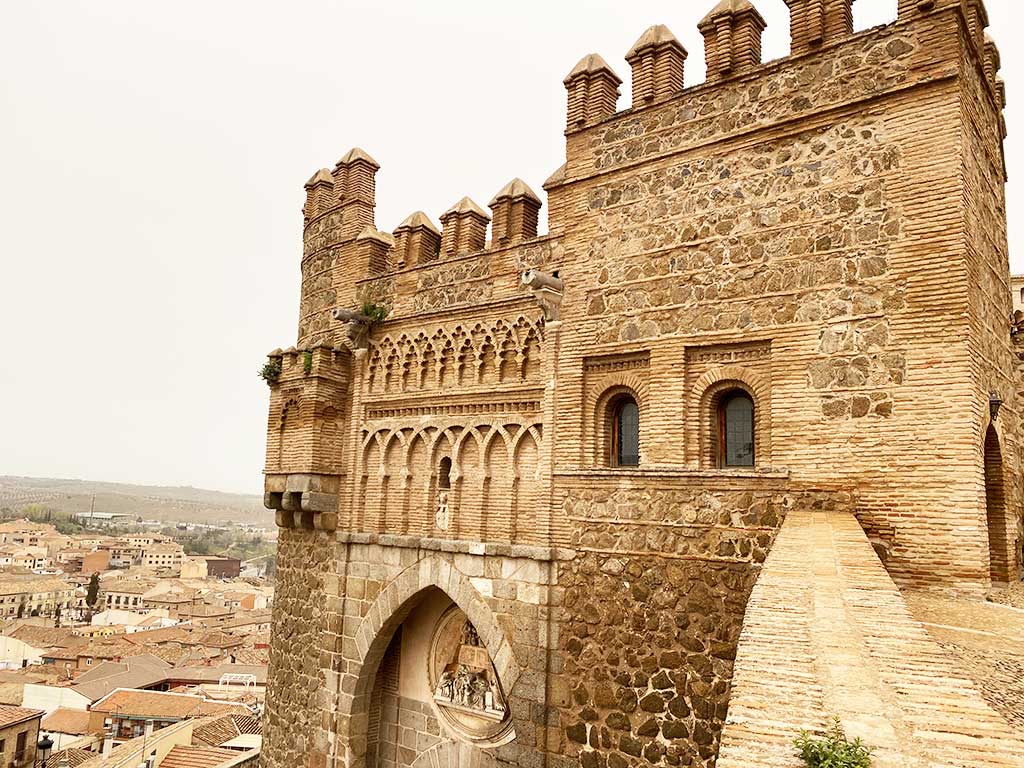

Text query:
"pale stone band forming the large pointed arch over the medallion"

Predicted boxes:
[[338, 555, 522, 724]]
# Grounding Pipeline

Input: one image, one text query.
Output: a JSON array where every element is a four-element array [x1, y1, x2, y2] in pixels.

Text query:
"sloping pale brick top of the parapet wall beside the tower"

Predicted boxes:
[[718, 512, 1024, 768]]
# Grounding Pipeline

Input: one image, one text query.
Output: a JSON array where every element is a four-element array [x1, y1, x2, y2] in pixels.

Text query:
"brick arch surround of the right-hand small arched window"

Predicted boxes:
[[686, 366, 772, 468]]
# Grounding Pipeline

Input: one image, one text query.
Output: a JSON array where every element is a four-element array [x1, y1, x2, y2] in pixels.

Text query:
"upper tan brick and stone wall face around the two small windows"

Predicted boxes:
[[549, 10, 998, 592]]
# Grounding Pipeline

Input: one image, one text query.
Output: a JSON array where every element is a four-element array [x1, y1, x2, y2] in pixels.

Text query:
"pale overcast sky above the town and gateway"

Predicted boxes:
[[0, 0, 1024, 493]]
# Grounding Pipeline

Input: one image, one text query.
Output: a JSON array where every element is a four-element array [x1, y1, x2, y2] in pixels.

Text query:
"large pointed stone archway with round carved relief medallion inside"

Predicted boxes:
[[339, 558, 521, 768]]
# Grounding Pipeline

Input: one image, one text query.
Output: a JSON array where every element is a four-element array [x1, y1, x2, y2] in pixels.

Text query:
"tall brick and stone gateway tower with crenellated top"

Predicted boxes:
[[263, 0, 1024, 768]]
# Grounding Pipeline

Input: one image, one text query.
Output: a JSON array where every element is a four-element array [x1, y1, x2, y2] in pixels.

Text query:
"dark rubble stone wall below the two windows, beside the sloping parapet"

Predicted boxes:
[[554, 476, 852, 768]]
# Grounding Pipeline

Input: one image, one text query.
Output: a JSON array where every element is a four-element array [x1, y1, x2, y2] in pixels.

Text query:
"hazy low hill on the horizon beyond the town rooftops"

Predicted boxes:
[[0, 475, 273, 527]]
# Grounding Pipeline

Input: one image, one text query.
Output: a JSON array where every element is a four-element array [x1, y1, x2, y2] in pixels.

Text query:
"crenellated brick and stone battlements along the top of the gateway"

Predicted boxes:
[[292, 0, 1006, 354]]
